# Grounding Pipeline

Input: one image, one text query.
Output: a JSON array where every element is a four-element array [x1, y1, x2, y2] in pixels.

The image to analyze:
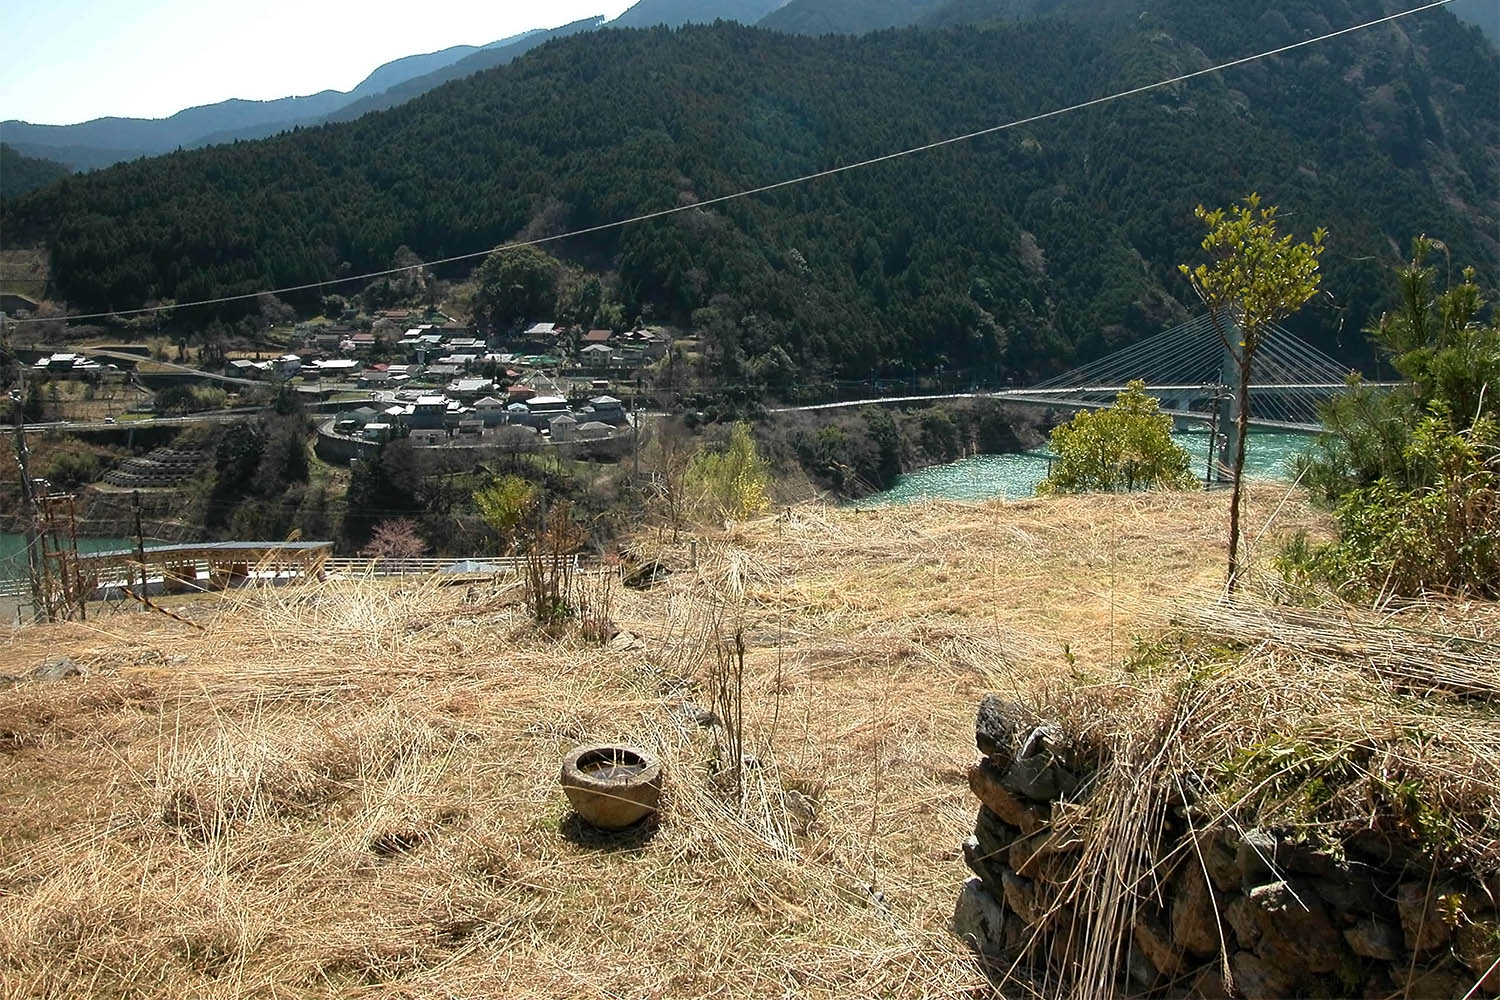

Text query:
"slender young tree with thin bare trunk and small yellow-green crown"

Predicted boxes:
[[1181, 193, 1325, 594]]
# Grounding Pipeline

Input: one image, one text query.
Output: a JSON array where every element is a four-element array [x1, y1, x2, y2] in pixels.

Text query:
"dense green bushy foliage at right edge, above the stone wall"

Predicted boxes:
[[1280, 238, 1500, 598]]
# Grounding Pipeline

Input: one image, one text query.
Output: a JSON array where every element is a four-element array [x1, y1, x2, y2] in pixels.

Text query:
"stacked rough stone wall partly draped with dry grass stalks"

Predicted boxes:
[[954, 697, 1500, 999]]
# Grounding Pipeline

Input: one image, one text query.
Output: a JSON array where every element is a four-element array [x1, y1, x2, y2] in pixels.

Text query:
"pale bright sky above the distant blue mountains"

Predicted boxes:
[[0, 0, 630, 125]]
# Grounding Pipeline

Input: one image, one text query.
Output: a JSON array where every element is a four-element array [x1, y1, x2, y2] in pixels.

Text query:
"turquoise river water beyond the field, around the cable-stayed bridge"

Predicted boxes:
[[854, 430, 1313, 507]]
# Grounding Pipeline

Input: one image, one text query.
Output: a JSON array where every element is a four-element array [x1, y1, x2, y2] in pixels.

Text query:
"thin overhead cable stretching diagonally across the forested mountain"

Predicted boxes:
[[11, 0, 1451, 325]]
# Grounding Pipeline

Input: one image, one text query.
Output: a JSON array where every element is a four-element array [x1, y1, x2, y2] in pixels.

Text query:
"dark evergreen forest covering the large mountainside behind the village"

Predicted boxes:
[[0, 0, 1500, 379]]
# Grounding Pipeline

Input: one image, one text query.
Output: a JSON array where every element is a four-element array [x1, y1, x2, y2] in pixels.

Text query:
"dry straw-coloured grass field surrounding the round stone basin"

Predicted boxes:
[[0, 487, 1464, 1000]]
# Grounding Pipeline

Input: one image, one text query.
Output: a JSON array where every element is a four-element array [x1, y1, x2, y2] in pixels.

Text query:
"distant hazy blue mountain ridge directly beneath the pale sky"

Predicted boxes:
[[0, 21, 558, 169]]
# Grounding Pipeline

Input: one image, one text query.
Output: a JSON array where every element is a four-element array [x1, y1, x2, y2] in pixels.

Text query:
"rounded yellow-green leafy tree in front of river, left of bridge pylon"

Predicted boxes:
[[1037, 381, 1197, 493]]
